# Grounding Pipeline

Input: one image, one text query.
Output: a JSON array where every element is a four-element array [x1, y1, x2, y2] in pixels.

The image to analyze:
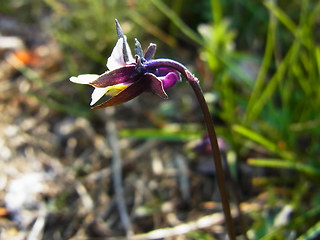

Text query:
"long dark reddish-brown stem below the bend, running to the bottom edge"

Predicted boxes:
[[188, 79, 236, 240]]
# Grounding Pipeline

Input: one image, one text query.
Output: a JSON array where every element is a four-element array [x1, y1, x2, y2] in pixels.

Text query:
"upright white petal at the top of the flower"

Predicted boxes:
[[107, 38, 134, 71]]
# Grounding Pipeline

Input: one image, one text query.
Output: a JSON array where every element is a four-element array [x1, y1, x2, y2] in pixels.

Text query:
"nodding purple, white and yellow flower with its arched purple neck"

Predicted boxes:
[[70, 20, 185, 109]]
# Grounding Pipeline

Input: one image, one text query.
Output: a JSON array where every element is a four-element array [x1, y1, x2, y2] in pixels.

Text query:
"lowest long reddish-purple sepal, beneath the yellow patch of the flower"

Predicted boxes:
[[92, 78, 148, 109]]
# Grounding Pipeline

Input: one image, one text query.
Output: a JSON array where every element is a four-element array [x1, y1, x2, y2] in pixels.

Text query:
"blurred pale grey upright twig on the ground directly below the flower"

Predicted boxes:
[[106, 108, 133, 238]]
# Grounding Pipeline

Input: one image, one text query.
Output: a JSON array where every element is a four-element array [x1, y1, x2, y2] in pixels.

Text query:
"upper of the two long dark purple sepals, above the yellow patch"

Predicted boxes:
[[90, 65, 139, 88]]
